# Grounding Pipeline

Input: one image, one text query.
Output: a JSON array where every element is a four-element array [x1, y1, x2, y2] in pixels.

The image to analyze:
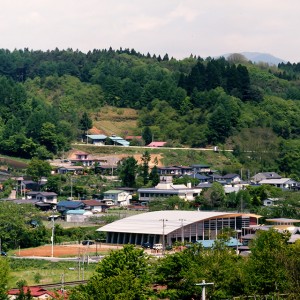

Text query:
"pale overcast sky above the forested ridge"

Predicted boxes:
[[0, 0, 300, 62]]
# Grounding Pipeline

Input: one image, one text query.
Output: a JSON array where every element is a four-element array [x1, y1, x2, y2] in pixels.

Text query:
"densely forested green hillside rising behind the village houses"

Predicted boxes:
[[0, 49, 300, 177]]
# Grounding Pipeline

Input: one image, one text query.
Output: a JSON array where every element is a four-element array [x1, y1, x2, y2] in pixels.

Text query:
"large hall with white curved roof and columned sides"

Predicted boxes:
[[97, 210, 260, 245]]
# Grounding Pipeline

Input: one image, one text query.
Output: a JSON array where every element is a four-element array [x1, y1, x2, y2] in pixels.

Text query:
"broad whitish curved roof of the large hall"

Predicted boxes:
[[97, 210, 260, 234]]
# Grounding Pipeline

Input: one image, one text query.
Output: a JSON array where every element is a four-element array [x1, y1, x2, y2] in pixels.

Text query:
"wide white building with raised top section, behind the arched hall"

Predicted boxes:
[[138, 176, 202, 202]]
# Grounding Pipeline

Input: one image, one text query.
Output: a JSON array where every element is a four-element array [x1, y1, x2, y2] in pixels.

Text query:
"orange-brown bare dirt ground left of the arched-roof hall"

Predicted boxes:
[[13, 244, 122, 257]]
